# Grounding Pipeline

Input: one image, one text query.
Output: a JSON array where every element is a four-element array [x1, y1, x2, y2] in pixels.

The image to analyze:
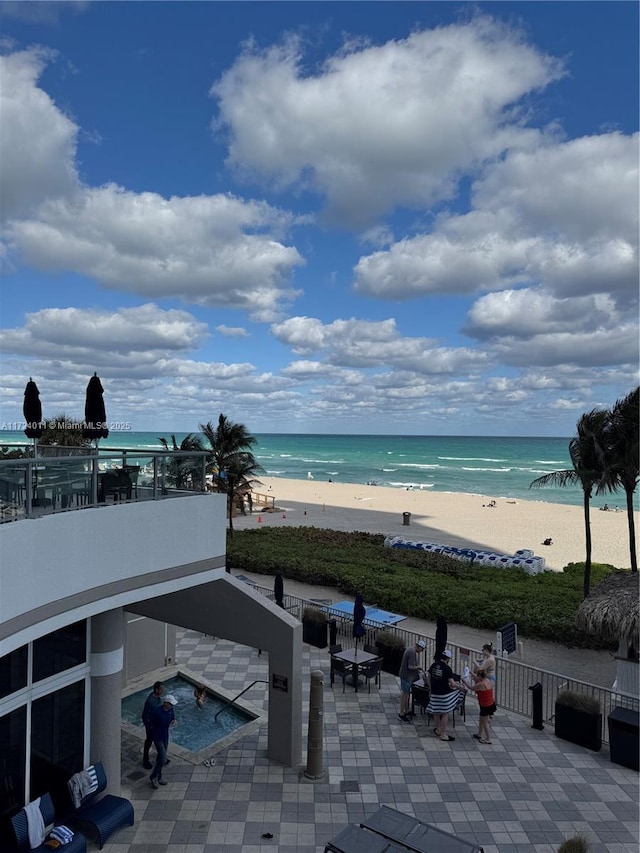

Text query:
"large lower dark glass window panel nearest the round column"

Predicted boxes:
[[30, 679, 85, 804]]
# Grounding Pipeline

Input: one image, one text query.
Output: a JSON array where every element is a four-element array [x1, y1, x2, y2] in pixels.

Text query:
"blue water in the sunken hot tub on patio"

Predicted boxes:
[[122, 675, 255, 752]]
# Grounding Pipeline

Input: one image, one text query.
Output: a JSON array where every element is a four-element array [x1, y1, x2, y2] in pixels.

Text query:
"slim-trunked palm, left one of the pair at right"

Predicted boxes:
[[529, 409, 609, 598]]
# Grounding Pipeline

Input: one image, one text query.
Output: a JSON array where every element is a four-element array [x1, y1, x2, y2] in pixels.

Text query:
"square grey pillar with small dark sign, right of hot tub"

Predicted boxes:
[[267, 624, 302, 767]]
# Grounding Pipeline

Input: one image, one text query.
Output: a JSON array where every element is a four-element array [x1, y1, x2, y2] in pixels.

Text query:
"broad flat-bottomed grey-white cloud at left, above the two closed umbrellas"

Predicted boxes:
[[9, 186, 303, 321]]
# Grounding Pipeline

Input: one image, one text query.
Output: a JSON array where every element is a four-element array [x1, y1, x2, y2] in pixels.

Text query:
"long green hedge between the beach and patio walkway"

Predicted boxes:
[[227, 527, 614, 648]]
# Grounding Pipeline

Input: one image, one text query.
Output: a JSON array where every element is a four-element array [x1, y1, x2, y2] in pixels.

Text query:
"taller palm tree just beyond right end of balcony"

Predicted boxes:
[[200, 414, 264, 535]]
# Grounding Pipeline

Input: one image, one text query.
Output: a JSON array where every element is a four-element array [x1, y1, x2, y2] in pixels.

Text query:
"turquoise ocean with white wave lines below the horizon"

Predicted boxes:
[[0, 431, 625, 508]]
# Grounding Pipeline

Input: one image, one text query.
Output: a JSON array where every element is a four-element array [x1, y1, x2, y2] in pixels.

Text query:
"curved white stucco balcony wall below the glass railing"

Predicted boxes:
[[0, 495, 226, 656]]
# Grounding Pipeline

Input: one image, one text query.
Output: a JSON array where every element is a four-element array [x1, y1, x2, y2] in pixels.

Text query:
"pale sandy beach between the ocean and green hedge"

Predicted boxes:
[[234, 477, 640, 571]]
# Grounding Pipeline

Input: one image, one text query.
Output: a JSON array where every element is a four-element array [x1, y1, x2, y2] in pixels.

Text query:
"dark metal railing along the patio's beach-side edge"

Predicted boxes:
[[244, 583, 640, 743]]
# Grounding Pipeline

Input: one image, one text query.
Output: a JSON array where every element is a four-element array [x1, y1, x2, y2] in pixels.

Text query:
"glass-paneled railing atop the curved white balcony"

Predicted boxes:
[[0, 447, 212, 523]]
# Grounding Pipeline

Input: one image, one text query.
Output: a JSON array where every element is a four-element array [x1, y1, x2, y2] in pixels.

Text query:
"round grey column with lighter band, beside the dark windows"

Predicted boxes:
[[90, 608, 125, 794]]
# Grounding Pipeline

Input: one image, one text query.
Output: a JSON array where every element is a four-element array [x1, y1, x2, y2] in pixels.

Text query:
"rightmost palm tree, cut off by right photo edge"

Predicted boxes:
[[598, 387, 640, 572]]
